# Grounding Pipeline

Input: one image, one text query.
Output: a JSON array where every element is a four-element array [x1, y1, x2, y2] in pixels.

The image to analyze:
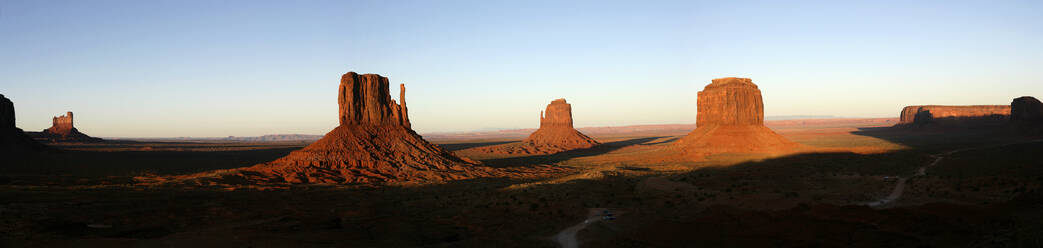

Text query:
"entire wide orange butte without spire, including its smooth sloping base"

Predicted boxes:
[[675, 77, 801, 159]]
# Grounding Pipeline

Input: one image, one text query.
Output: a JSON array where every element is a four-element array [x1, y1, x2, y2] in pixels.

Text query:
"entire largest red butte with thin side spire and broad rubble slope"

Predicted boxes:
[[208, 72, 491, 183]]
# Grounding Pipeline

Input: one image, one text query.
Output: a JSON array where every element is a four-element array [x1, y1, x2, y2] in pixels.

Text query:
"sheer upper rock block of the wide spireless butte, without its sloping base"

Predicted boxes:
[[696, 77, 765, 127]]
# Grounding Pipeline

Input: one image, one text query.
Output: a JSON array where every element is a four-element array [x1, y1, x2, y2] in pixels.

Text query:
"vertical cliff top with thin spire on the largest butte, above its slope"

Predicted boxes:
[[337, 72, 410, 128]]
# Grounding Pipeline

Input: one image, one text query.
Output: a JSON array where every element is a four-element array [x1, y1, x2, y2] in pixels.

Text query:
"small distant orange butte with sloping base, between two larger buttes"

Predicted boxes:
[[478, 98, 601, 154]]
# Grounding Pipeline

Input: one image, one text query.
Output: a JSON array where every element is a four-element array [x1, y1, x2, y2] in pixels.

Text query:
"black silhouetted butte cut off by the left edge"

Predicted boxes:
[[0, 95, 47, 154]]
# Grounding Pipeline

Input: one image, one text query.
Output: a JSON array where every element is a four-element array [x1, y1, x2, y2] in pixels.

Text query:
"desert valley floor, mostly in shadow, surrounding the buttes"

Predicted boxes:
[[0, 119, 1043, 247]]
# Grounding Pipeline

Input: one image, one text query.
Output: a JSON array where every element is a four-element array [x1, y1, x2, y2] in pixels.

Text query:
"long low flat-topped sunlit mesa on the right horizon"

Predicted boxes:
[[898, 105, 1011, 126]]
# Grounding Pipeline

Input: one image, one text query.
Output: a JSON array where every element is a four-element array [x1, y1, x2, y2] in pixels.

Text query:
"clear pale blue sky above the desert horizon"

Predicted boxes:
[[0, 0, 1043, 138]]
